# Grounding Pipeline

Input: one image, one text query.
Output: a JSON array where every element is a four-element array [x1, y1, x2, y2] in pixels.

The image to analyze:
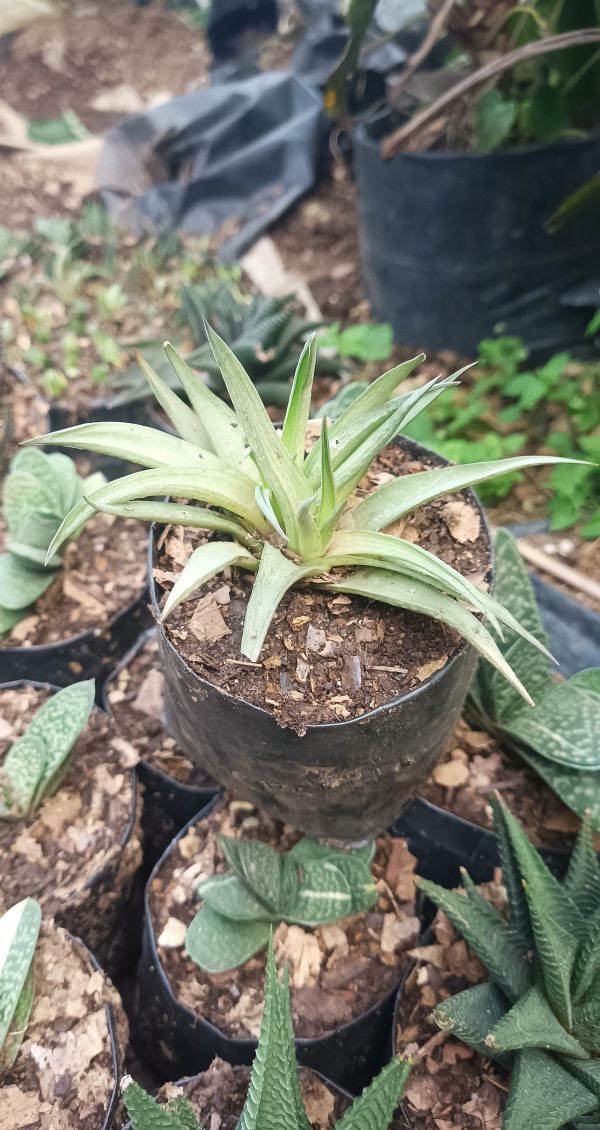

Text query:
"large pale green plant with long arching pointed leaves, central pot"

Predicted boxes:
[[34, 327, 583, 702]]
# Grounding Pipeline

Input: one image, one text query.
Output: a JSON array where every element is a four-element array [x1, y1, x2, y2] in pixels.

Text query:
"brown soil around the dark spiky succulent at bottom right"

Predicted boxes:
[[395, 872, 507, 1130]]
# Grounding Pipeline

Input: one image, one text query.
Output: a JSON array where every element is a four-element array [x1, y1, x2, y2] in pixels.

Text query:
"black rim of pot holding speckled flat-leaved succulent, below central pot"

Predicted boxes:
[[144, 797, 403, 1053]]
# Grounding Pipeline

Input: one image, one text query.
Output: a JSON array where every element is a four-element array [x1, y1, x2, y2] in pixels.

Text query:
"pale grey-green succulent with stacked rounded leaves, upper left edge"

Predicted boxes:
[[0, 449, 104, 635]]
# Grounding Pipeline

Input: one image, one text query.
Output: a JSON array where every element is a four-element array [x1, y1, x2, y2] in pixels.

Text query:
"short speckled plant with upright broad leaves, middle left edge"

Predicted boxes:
[[0, 679, 95, 823]]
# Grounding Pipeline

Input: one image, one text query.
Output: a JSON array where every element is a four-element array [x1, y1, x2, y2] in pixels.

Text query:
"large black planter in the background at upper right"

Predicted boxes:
[[355, 120, 600, 357]]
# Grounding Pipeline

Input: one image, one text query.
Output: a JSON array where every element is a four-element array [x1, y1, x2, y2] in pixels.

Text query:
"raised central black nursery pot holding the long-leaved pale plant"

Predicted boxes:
[[148, 437, 492, 841]]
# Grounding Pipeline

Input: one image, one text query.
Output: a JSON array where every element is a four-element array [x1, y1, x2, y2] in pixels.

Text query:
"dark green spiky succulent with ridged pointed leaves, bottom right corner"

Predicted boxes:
[[419, 799, 600, 1130]]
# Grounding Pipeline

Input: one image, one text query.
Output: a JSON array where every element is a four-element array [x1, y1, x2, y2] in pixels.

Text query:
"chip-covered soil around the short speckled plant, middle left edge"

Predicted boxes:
[[0, 685, 141, 968]]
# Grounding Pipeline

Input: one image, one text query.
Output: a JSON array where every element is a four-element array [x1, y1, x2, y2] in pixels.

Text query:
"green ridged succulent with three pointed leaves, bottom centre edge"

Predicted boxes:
[[123, 946, 410, 1130]]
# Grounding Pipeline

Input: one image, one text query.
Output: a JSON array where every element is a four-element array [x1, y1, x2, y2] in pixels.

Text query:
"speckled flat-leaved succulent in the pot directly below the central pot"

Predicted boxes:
[[185, 836, 377, 973]]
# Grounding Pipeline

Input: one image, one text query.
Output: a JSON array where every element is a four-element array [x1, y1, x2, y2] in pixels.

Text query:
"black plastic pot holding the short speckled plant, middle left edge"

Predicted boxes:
[[0, 679, 144, 981]]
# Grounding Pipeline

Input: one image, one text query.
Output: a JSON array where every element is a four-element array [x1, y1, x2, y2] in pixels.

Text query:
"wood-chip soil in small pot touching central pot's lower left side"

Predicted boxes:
[[106, 636, 215, 786]]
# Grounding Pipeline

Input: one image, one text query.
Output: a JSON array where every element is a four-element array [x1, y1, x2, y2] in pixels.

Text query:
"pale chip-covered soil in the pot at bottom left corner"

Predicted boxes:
[[0, 922, 128, 1130]]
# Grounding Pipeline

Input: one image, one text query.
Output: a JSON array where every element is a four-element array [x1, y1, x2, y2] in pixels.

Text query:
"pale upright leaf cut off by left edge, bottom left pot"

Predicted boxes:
[[0, 898, 42, 1078]]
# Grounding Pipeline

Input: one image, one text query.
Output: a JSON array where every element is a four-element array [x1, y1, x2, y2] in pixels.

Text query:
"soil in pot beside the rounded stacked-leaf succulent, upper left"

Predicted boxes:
[[0, 514, 147, 647]]
